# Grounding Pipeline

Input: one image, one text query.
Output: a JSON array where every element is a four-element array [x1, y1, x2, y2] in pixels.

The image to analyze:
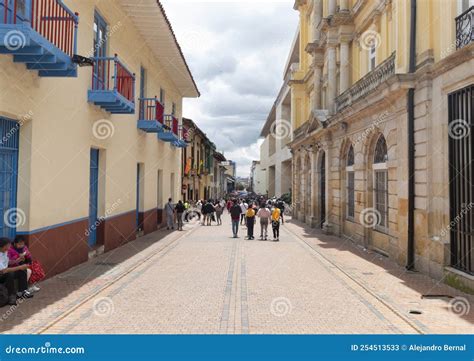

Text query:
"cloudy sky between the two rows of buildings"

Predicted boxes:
[[162, 0, 298, 176]]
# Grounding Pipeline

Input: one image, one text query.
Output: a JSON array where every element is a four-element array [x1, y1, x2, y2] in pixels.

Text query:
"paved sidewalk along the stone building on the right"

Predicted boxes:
[[286, 220, 474, 334]]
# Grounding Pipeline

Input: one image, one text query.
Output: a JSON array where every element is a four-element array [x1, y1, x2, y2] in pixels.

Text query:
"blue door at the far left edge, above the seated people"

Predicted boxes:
[[0, 118, 19, 239]]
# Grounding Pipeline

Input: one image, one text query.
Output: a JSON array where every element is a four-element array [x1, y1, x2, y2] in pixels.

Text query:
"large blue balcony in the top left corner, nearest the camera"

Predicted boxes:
[[0, 0, 79, 77]]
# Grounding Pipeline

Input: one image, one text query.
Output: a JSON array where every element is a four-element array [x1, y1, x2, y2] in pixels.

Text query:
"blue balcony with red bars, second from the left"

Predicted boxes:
[[87, 54, 135, 114]]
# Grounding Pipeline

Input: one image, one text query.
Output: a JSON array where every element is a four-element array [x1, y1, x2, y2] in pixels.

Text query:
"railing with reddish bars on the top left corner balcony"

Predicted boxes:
[[0, 0, 79, 57]]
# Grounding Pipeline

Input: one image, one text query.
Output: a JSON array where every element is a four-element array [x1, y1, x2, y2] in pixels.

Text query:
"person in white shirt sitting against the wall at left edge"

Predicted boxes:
[[0, 238, 33, 306]]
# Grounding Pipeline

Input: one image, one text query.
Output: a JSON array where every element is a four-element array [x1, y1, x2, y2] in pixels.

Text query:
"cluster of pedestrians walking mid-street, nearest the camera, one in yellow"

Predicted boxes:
[[231, 199, 284, 242]]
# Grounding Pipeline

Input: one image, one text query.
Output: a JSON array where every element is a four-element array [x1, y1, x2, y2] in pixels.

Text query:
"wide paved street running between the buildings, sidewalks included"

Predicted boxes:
[[1, 214, 474, 334]]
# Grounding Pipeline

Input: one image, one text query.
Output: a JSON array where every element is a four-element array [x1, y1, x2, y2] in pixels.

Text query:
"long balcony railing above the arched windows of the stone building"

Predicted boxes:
[[336, 53, 395, 112]]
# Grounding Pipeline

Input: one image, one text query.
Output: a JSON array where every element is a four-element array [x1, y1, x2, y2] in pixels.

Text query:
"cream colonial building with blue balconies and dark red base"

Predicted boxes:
[[0, 0, 199, 276]]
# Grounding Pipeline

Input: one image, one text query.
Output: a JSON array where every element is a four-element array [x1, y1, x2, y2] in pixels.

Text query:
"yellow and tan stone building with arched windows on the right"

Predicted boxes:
[[289, 0, 474, 289]]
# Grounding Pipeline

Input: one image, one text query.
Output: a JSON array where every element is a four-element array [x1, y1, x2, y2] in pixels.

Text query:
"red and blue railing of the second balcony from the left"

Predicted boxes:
[[92, 54, 135, 103]]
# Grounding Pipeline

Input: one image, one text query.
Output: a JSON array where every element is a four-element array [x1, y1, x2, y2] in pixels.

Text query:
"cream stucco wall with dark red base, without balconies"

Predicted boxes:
[[0, 0, 199, 276]]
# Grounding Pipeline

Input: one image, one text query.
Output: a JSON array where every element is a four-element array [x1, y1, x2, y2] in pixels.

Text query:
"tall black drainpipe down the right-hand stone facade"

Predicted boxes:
[[406, 0, 416, 271]]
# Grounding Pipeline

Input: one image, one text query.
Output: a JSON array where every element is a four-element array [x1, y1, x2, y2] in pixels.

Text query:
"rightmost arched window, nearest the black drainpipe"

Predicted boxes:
[[372, 135, 388, 230]]
